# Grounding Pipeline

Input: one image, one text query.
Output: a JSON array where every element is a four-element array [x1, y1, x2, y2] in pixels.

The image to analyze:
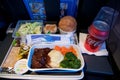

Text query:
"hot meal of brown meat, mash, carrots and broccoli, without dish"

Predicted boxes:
[[31, 45, 81, 69]]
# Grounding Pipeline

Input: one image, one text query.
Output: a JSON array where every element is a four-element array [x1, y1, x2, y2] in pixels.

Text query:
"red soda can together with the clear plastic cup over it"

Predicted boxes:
[[84, 6, 119, 52]]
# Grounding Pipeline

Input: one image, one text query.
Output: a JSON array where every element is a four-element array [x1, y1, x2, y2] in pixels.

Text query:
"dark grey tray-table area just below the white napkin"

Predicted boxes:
[[83, 55, 113, 75]]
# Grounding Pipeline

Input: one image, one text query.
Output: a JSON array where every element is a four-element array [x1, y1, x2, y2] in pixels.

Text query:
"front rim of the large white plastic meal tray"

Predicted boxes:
[[0, 71, 84, 80]]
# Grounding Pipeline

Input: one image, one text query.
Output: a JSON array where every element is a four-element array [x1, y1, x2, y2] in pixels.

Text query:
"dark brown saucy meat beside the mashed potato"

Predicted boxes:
[[31, 48, 51, 68]]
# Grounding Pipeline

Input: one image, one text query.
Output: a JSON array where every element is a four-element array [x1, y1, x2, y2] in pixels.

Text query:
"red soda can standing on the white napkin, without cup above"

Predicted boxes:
[[84, 21, 109, 52]]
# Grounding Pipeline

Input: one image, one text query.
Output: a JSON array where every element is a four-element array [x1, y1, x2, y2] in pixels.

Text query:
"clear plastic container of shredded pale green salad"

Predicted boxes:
[[12, 20, 43, 38]]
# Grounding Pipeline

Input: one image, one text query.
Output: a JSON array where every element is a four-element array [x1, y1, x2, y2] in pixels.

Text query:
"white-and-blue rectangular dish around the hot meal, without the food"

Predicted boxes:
[[27, 44, 85, 72]]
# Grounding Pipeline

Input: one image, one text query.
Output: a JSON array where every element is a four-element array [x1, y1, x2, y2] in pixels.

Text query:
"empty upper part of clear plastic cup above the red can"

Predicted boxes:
[[94, 6, 119, 27]]
